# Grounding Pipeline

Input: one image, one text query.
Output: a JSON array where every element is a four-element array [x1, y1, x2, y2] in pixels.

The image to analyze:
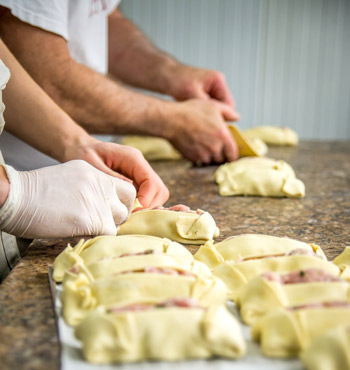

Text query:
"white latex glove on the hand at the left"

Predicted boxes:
[[0, 160, 136, 238]]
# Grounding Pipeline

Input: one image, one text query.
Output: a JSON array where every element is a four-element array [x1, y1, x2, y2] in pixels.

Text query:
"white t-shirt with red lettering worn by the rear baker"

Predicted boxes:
[[0, 0, 120, 74]]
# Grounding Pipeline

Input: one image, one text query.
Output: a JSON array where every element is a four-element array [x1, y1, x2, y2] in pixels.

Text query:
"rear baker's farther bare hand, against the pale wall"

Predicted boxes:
[[169, 64, 239, 121]]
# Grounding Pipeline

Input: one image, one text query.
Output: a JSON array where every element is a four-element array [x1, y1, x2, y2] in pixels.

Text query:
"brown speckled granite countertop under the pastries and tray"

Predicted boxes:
[[0, 141, 350, 370]]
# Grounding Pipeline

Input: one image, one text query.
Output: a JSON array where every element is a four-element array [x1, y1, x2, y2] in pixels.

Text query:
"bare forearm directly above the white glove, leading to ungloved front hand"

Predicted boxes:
[[0, 41, 93, 161]]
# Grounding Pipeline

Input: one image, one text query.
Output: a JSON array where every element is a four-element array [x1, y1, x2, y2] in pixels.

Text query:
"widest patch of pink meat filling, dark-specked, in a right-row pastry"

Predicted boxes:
[[261, 268, 343, 284]]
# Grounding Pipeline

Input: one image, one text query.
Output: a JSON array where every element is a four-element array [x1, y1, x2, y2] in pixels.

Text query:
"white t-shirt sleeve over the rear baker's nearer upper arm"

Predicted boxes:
[[0, 0, 69, 40]]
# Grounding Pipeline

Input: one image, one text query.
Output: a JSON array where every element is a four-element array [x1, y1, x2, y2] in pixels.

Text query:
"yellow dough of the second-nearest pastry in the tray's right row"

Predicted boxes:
[[252, 307, 350, 357]]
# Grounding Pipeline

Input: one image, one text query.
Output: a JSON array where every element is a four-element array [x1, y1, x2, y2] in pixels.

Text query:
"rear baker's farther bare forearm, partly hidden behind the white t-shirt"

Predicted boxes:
[[108, 10, 179, 94]]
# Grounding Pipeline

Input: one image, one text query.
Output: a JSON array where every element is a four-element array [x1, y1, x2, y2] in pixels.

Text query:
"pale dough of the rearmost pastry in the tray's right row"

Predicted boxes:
[[194, 234, 326, 268]]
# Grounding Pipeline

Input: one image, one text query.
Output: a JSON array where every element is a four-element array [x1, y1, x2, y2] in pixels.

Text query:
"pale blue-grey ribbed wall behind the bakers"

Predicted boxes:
[[122, 0, 350, 139]]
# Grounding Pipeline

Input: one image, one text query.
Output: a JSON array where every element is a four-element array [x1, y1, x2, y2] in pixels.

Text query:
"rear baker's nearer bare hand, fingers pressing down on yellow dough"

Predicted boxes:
[[165, 99, 238, 164]]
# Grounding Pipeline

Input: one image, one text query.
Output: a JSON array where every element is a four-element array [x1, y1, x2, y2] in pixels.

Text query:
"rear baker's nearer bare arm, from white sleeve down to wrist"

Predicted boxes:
[[0, 13, 173, 136]]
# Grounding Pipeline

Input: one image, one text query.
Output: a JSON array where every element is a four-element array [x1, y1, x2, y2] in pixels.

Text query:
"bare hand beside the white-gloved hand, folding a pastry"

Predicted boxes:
[[66, 140, 169, 208]]
